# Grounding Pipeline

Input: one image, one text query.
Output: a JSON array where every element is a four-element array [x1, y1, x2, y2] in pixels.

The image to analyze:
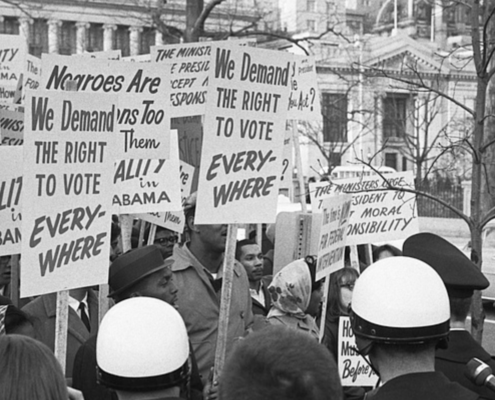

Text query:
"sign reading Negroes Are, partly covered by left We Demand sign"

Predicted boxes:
[[41, 54, 170, 159]]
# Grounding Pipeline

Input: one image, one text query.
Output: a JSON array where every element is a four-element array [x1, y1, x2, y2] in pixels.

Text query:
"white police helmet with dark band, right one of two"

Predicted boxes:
[[351, 257, 450, 354]]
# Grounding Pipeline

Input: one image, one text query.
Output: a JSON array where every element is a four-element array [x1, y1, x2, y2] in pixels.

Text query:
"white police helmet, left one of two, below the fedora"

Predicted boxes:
[[96, 297, 189, 391]]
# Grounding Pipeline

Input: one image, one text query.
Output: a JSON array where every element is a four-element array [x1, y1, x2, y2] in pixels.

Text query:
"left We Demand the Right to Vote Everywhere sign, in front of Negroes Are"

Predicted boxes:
[[21, 91, 117, 297]]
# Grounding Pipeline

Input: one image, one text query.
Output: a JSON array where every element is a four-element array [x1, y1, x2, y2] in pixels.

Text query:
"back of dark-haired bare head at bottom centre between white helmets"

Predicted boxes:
[[219, 326, 342, 400]]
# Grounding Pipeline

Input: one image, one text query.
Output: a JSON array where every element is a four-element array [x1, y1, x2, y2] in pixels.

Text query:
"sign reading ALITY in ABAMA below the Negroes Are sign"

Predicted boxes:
[[113, 131, 181, 214]]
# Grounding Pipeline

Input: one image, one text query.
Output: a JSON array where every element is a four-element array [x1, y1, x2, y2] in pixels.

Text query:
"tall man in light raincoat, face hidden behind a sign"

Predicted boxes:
[[172, 193, 253, 383]]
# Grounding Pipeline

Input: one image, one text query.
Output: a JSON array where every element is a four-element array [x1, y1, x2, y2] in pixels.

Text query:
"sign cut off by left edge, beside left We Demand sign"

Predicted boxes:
[[0, 146, 23, 256]]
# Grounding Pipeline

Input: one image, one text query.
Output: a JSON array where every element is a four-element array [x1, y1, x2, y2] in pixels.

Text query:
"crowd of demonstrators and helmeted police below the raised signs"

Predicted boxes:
[[0, 195, 495, 400]]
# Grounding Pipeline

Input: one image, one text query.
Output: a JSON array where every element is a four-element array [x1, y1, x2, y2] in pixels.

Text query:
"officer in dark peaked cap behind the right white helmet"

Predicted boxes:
[[403, 233, 495, 399]]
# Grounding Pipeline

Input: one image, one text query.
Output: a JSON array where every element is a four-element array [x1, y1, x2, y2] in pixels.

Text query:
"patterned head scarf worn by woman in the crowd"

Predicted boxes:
[[268, 260, 311, 318]]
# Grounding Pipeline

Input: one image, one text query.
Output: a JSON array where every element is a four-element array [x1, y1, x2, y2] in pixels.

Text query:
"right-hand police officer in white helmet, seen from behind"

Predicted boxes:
[[351, 256, 478, 400]]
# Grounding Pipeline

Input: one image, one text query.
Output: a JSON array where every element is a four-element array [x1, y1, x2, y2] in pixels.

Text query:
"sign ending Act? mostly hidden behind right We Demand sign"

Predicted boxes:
[[287, 56, 321, 120]]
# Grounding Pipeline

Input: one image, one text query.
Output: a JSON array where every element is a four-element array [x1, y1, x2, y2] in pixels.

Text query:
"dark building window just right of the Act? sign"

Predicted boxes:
[[322, 93, 347, 143]]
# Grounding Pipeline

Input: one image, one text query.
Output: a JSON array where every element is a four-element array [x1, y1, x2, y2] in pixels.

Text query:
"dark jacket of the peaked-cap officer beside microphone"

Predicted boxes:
[[435, 330, 495, 400]]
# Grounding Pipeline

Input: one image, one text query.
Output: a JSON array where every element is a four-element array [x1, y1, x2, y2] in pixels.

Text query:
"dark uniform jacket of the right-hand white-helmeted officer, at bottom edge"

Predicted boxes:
[[365, 372, 480, 400]]
